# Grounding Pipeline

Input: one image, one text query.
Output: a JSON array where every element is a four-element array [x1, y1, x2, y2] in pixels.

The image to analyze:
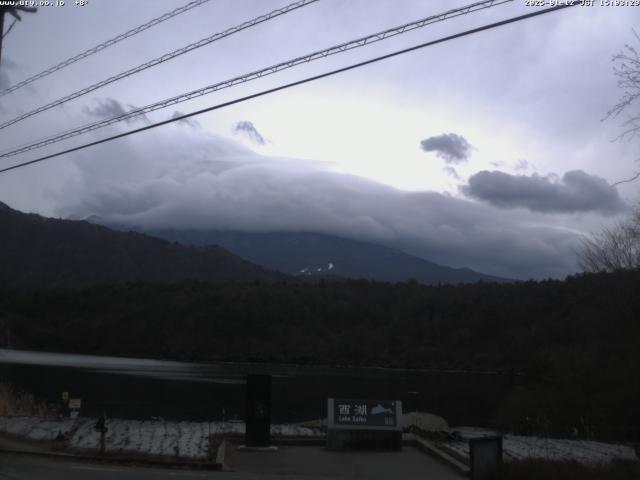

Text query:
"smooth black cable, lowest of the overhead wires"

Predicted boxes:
[[0, 3, 579, 173]]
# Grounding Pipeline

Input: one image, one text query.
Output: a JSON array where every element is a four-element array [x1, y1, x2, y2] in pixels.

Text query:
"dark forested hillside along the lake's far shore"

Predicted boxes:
[[0, 271, 640, 434]]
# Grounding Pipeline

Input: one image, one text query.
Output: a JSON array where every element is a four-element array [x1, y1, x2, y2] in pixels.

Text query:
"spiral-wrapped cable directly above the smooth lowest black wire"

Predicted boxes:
[[0, 0, 513, 158]]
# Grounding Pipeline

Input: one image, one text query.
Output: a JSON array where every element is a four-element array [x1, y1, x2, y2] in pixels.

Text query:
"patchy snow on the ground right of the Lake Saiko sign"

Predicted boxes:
[[441, 427, 638, 464]]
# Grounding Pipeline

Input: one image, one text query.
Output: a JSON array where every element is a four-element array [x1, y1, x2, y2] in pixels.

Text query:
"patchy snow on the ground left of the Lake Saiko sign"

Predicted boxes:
[[0, 417, 324, 460]]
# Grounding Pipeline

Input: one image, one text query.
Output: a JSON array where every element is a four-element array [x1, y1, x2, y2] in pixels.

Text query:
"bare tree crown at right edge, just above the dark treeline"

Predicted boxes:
[[580, 206, 640, 272]]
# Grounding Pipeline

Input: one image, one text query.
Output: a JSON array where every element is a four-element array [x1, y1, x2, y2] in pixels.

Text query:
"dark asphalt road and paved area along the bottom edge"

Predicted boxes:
[[0, 447, 463, 480]]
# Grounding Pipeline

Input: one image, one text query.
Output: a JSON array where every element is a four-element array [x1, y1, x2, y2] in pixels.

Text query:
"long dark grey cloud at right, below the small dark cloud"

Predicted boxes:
[[461, 170, 627, 213]]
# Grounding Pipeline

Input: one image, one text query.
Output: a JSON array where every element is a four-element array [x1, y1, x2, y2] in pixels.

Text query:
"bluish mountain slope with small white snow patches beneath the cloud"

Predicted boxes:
[[148, 230, 507, 284]]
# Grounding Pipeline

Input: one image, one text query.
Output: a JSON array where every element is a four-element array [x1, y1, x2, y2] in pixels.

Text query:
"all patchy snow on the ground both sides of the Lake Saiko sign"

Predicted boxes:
[[0, 413, 637, 464]]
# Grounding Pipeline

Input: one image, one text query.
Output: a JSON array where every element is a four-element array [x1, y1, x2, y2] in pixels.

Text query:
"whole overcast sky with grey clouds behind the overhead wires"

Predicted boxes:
[[0, 0, 640, 278]]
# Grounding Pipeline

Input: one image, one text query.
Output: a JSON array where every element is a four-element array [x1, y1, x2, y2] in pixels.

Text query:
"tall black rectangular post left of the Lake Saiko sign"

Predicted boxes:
[[245, 375, 271, 447]]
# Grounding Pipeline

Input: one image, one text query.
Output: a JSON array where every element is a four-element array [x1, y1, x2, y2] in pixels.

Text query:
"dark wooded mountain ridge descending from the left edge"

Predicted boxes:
[[0, 202, 283, 288]]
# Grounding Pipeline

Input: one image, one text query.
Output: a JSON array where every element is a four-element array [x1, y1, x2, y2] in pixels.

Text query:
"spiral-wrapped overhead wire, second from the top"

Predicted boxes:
[[0, 0, 318, 130]]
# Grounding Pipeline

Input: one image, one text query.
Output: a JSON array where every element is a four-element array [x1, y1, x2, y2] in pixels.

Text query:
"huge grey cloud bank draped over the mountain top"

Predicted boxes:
[[28, 128, 580, 278]]
